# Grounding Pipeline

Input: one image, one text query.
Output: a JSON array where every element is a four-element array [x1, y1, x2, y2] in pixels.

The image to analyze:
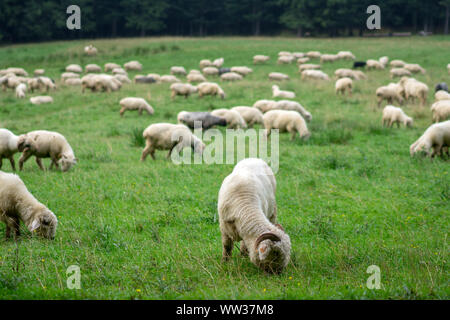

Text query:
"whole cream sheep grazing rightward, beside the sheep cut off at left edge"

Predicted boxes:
[[17, 130, 77, 172]]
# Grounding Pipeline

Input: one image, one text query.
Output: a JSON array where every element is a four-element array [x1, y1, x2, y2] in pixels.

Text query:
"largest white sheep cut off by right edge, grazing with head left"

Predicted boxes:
[[409, 120, 450, 158]]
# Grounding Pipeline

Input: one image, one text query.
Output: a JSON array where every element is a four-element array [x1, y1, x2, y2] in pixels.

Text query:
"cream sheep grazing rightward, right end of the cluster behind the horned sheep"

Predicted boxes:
[[263, 110, 311, 140]]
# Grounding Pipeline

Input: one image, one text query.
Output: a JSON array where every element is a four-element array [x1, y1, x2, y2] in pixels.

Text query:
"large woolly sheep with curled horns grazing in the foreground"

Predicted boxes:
[[217, 158, 291, 273]]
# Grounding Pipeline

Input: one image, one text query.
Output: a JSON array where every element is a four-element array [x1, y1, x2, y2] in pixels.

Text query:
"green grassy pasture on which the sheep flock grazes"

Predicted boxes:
[[0, 36, 450, 299]]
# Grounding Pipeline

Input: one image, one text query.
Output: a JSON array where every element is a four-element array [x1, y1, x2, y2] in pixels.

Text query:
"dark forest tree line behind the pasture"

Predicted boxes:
[[0, 0, 450, 43]]
